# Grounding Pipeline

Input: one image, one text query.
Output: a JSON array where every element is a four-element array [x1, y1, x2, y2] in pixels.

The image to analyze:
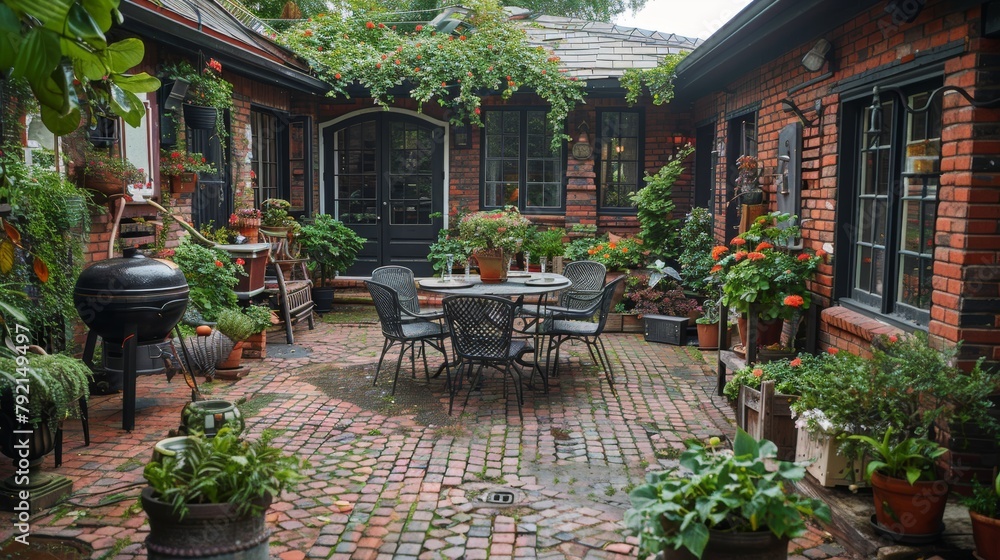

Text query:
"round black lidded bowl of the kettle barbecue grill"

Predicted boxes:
[[73, 248, 189, 345]]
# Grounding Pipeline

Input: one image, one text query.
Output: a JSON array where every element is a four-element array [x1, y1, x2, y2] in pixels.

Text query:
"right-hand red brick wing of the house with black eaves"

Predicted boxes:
[[672, 0, 1000, 374]]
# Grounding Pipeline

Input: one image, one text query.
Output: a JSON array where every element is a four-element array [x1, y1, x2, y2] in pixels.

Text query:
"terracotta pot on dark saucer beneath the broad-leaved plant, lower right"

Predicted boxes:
[[872, 471, 948, 535]]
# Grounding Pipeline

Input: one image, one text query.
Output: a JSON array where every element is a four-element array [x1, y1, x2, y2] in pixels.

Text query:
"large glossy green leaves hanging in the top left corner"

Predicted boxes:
[[0, 0, 160, 135]]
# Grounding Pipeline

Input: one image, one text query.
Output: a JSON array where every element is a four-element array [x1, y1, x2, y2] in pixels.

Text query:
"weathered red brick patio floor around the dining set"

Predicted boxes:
[[0, 322, 845, 560]]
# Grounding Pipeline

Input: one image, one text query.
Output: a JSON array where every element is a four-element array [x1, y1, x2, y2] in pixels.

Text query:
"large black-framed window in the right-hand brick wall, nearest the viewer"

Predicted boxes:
[[841, 84, 941, 325]]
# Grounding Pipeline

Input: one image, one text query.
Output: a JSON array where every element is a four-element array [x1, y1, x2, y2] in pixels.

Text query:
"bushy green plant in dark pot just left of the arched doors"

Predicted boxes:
[[296, 214, 365, 313]]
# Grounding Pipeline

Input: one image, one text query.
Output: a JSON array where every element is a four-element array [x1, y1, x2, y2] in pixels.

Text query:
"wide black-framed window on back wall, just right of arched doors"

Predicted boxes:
[[482, 110, 564, 212]]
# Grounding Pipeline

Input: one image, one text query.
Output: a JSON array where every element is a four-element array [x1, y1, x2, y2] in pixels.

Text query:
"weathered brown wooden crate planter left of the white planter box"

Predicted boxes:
[[737, 381, 797, 461]]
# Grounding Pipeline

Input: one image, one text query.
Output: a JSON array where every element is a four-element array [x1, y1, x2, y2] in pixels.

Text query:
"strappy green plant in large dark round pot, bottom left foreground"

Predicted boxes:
[[141, 427, 308, 558]]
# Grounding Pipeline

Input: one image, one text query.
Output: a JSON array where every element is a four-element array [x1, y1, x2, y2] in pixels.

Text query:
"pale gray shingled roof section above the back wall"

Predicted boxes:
[[522, 15, 701, 80]]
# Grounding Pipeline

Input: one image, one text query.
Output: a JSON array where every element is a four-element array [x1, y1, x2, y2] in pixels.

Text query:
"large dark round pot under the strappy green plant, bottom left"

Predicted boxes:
[[142, 487, 271, 560]]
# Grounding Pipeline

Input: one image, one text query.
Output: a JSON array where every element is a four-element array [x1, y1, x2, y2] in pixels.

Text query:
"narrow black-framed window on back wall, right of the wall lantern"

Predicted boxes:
[[597, 111, 643, 212]]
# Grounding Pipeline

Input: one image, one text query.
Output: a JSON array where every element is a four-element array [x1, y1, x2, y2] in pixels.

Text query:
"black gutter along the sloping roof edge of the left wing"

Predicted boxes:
[[119, 2, 330, 95]]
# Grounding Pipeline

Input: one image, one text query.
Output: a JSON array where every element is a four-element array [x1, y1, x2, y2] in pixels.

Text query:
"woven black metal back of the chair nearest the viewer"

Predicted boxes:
[[443, 296, 521, 361]]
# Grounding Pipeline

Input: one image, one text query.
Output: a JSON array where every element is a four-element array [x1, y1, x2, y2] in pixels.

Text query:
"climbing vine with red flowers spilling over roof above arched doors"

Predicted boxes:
[[280, 0, 584, 149]]
